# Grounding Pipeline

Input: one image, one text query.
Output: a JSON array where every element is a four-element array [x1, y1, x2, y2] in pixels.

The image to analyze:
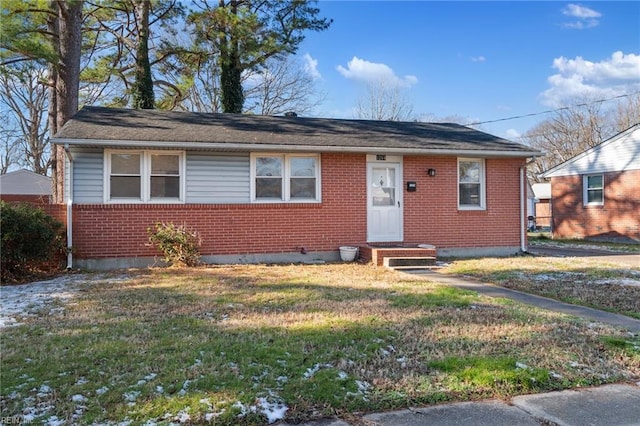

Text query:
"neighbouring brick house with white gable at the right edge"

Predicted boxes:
[[542, 123, 640, 241]]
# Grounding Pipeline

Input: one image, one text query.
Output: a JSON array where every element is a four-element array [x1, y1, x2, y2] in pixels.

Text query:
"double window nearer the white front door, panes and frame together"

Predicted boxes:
[[251, 154, 320, 202]]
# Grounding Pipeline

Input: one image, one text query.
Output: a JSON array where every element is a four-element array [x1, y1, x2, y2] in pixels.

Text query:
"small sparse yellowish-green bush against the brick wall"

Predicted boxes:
[[147, 223, 201, 267]]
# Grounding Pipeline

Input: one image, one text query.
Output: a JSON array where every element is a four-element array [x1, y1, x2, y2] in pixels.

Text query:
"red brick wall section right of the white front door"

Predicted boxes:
[[404, 157, 526, 248]]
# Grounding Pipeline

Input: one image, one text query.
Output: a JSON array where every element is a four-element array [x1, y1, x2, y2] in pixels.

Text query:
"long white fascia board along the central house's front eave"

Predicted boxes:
[[51, 138, 544, 158]]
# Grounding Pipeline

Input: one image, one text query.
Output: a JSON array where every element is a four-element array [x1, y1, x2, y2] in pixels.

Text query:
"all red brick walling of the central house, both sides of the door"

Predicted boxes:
[[53, 154, 523, 259]]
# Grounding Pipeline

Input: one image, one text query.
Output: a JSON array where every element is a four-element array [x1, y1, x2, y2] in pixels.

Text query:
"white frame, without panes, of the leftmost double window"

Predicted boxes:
[[104, 149, 186, 204]]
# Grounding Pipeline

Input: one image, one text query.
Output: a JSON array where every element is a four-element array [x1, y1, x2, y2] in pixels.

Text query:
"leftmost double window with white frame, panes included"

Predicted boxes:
[[104, 150, 184, 203]]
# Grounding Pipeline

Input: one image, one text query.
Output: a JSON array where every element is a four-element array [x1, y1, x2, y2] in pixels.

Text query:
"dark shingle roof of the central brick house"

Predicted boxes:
[[53, 107, 539, 157]]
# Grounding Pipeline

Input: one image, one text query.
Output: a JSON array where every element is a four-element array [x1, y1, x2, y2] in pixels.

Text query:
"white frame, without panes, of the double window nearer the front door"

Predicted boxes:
[[250, 152, 322, 203]]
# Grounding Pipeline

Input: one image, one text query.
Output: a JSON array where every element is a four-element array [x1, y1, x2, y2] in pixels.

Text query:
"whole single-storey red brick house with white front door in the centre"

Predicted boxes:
[[52, 107, 541, 269]]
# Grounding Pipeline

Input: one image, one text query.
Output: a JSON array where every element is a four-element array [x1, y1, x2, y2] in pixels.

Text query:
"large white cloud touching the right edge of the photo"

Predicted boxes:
[[540, 51, 640, 108]]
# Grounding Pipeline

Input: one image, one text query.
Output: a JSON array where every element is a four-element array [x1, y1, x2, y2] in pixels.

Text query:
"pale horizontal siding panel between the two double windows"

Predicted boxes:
[[186, 152, 251, 204]]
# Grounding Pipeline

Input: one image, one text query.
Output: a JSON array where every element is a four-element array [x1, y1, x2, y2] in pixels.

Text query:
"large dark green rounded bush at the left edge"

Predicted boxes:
[[0, 201, 64, 282]]
